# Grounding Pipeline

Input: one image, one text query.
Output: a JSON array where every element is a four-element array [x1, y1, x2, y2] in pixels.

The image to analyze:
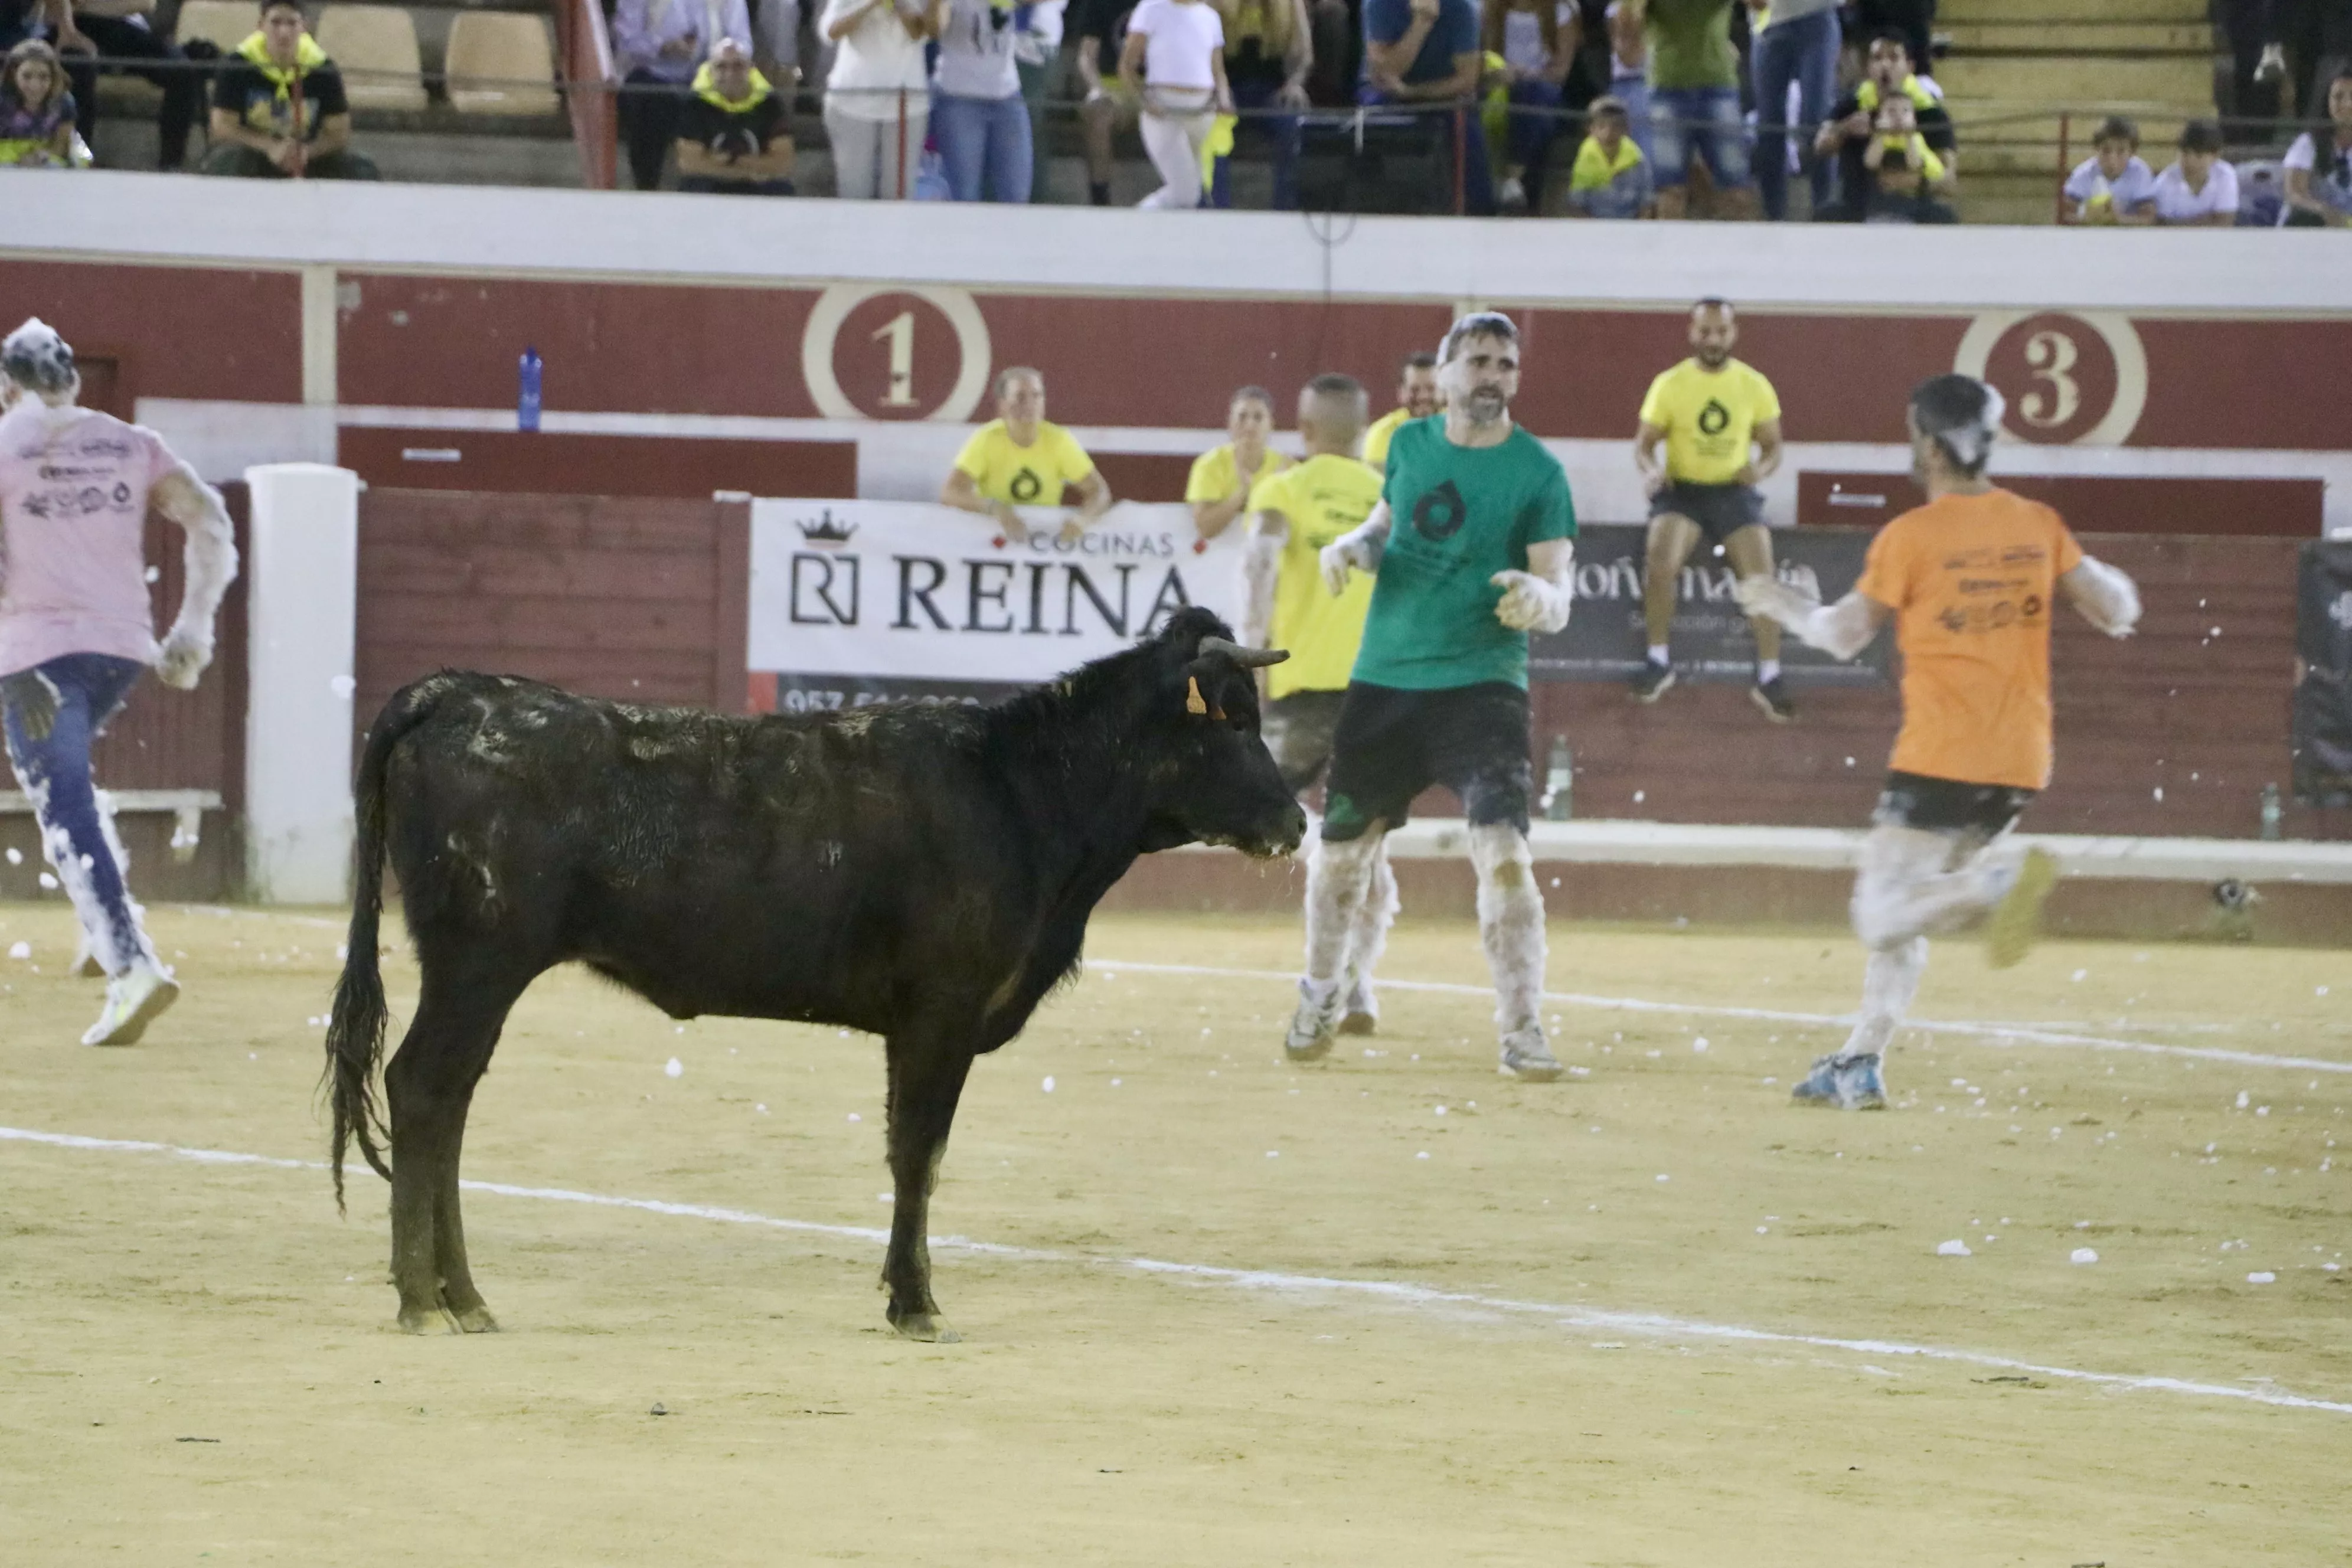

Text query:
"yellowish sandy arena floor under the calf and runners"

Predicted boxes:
[[0, 905, 2352, 1568]]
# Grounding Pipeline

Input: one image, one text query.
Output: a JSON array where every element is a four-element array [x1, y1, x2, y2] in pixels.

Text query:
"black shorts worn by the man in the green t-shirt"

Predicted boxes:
[[1322, 682, 1536, 844]]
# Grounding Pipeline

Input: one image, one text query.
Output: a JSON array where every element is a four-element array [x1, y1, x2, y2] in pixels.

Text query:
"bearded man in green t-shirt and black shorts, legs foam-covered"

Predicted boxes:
[[1282, 311, 1576, 1082]]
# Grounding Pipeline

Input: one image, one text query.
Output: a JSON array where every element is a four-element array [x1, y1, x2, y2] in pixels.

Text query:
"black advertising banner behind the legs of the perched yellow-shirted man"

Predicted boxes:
[[1529, 522, 1893, 687]]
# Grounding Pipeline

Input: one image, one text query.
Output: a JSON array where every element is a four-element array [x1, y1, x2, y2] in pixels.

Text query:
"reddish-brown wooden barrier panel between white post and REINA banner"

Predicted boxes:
[[355, 489, 750, 733]]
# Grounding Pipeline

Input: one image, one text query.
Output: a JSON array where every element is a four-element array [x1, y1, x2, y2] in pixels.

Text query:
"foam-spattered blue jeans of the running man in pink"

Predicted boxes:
[[0, 654, 153, 976]]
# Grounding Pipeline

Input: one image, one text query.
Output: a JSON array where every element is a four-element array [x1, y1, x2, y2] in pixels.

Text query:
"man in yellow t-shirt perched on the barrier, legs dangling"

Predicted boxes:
[[1632, 299, 1797, 724]]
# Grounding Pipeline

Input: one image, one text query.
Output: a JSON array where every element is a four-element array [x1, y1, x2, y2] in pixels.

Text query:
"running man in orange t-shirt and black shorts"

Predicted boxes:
[[1738, 376, 2140, 1110]]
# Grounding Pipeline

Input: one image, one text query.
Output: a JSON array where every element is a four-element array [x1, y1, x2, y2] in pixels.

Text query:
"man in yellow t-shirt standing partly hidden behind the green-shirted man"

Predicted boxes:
[[1242, 376, 1397, 1034]]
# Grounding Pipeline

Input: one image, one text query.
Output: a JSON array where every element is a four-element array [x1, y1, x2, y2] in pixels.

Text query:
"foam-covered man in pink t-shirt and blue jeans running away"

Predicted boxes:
[[0, 320, 237, 1046]]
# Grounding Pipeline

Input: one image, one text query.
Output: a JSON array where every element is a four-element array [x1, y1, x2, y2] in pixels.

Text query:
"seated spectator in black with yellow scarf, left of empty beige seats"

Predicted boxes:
[[205, 0, 381, 179]]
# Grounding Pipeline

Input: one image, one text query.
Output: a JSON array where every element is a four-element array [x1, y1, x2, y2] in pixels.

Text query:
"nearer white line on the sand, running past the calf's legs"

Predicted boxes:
[[0, 1126, 2352, 1415]]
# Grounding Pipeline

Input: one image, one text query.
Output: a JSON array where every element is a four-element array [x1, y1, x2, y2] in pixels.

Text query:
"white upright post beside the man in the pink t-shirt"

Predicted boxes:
[[244, 463, 360, 903]]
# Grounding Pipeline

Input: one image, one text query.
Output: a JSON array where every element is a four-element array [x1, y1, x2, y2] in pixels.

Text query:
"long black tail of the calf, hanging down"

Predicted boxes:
[[327, 682, 445, 1213]]
